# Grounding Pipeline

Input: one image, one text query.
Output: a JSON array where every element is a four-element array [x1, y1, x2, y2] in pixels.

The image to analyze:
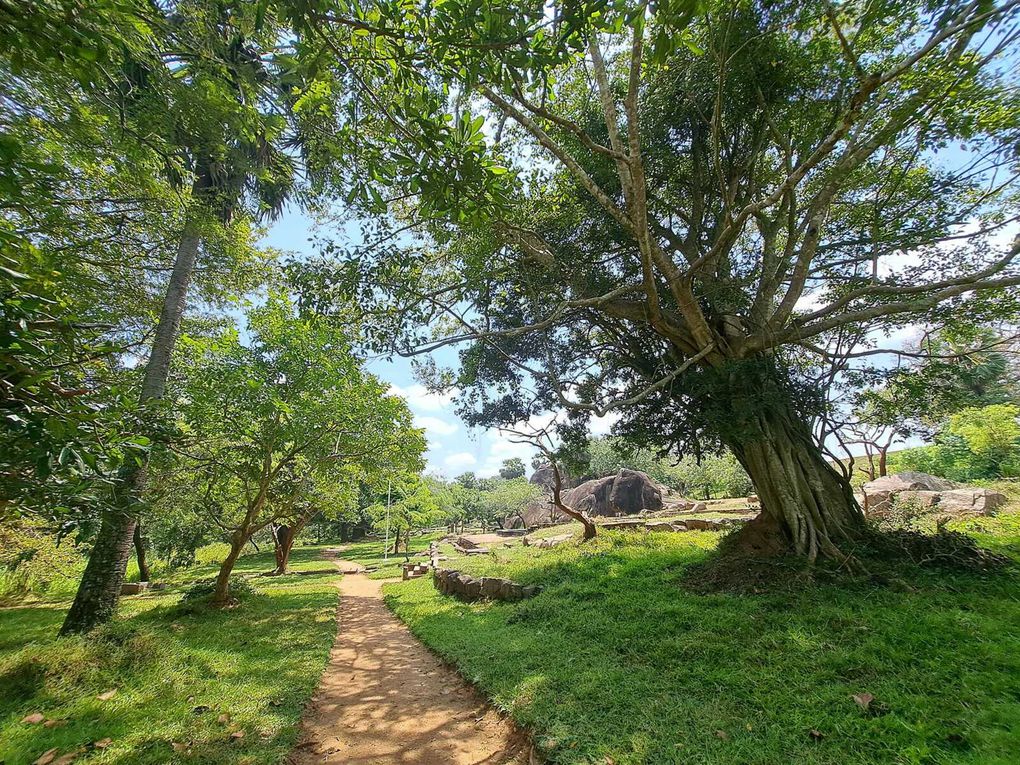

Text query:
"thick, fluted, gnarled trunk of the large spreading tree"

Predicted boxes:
[[726, 407, 864, 561]]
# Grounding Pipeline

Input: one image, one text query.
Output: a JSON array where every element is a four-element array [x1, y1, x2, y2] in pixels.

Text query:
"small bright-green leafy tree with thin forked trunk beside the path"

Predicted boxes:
[[174, 298, 424, 603]]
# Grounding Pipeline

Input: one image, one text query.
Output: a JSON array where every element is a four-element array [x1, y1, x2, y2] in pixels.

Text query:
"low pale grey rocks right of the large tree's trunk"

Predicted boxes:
[[864, 471, 1007, 517]]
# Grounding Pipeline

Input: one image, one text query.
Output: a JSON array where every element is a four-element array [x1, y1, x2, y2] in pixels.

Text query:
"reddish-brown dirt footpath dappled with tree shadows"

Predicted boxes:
[[290, 561, 529, 765]]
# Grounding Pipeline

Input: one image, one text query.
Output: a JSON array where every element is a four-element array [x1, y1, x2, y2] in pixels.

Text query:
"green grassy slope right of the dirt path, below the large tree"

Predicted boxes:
[[386, 511, 1020, 765]]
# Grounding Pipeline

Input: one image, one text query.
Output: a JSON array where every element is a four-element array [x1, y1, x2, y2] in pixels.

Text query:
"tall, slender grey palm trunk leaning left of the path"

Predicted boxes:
[[60, 213, 201, 634]]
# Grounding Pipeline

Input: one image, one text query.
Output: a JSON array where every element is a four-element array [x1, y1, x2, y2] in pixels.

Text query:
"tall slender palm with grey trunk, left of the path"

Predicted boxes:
[[61, 0, 295, 633]]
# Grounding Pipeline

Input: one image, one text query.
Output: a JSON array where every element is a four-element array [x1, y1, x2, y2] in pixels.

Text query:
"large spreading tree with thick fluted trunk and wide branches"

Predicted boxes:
[[287, 0, 1020, 559]]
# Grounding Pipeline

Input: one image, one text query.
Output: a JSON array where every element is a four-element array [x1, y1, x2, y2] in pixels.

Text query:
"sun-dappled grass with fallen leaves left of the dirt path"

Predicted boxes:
[[0, 548, 339, 765]]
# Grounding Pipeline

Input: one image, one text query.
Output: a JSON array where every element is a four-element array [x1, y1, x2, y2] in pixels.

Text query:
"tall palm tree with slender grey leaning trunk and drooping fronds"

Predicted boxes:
[[60, 0, 296, 634]]
